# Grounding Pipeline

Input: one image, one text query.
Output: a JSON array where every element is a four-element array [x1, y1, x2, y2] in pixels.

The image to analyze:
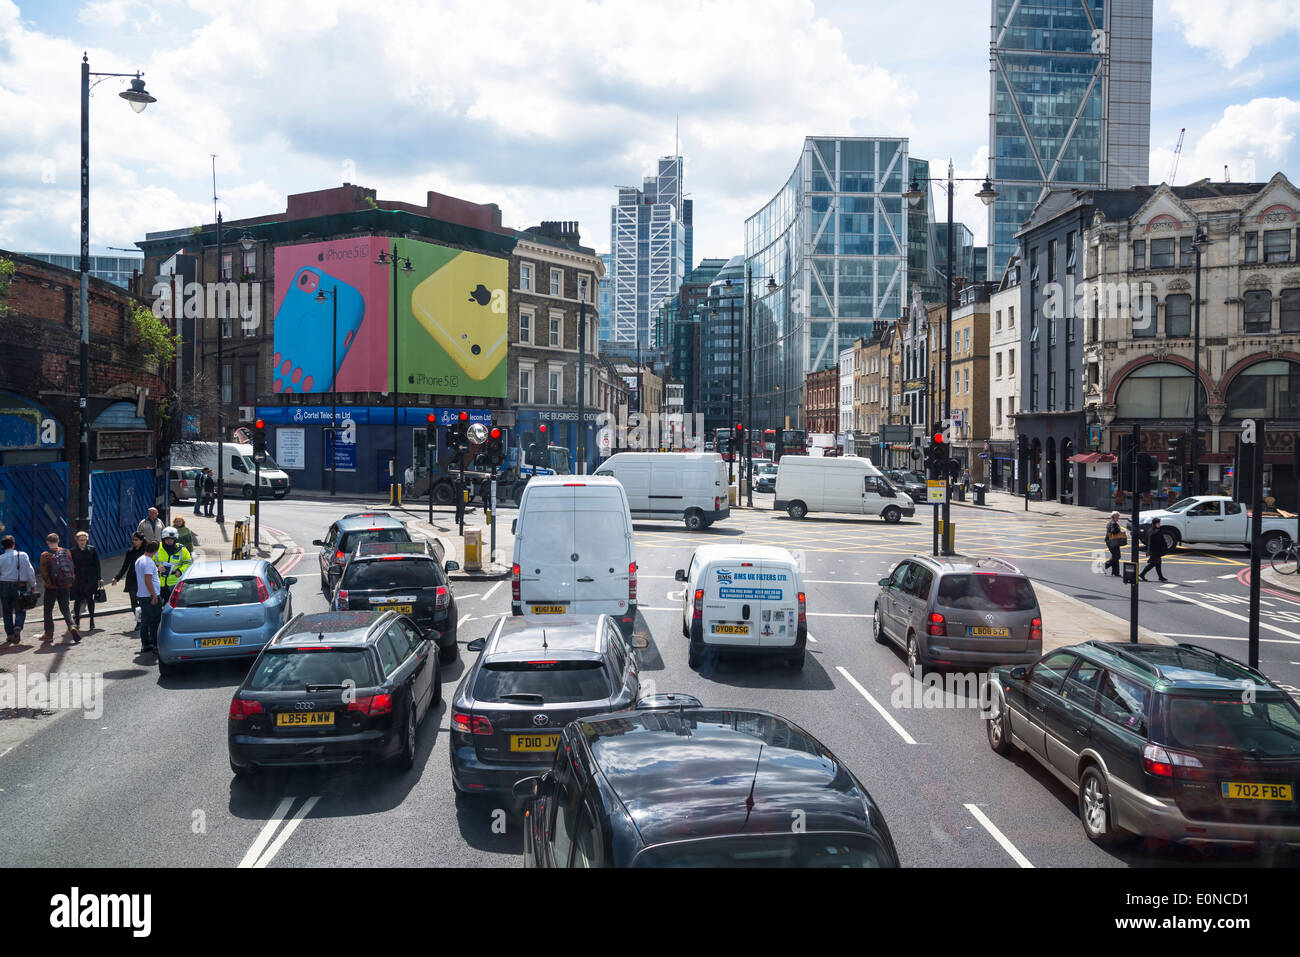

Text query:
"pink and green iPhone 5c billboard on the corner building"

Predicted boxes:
[[272, 237, 508, 398]]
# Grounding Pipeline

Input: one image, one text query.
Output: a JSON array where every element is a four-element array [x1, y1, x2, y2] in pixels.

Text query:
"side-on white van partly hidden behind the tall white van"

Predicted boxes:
[[595, 452, 731, 532]]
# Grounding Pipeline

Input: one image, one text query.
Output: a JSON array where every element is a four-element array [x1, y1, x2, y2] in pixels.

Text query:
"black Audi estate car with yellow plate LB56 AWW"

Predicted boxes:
[[228, 611, 442, 775]]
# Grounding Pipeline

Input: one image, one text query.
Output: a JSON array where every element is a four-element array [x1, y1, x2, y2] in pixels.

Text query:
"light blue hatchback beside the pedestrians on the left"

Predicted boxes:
[[159, 559, 298, 676]]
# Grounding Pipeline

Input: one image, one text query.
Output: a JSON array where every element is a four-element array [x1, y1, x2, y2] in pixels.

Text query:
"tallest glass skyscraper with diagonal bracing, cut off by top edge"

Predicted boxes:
[[988, 0, 1153, 280]]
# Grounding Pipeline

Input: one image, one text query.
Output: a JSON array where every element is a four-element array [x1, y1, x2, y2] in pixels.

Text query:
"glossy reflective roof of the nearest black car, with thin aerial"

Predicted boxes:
[[571, 707, 872, 845]]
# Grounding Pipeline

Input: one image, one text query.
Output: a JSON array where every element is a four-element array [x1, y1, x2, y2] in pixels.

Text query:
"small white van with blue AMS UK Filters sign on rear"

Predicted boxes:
[[676, 545, 809, 668]]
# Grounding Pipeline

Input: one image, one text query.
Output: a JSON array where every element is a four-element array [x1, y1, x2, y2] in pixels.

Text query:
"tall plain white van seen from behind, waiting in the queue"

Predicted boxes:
[[510, 476, 637, 636]]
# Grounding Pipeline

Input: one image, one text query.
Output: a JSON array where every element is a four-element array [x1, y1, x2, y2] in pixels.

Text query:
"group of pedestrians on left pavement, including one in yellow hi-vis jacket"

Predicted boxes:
[[0, 501, 192, 651]]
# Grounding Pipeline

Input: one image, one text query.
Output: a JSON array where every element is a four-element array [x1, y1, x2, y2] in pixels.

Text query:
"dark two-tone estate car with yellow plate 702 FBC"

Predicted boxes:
[[985, 641, 1300, 846]]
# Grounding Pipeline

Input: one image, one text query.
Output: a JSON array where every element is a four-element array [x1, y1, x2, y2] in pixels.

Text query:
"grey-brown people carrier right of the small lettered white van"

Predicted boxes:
[[872, 555, 1043, 677]]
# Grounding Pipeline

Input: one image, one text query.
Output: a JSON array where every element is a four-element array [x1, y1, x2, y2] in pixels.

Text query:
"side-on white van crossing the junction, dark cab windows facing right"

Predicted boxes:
[[772, 455, 917, 521]]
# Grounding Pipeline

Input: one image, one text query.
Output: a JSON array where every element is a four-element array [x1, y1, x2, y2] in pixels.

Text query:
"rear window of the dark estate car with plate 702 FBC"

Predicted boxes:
[[1165, 694, 1300, 757]]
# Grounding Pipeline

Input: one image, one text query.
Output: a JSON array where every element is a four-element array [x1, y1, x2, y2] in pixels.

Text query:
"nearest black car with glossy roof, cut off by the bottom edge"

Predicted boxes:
[[515, 696, 898, 867]]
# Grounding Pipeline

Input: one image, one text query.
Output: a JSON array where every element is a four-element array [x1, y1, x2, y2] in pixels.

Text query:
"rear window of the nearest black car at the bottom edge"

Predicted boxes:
[[632, 832, 893, 867]]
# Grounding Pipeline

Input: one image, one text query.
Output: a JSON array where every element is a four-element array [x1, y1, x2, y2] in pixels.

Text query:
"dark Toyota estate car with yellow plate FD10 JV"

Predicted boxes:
[[451, 615, 641, 794]]
